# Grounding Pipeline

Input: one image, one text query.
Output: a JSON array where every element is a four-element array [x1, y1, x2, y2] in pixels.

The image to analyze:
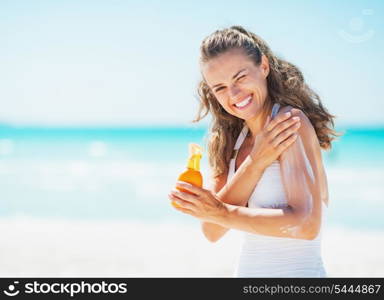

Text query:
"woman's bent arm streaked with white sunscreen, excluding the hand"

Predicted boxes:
[[207, 110, 328, 240]]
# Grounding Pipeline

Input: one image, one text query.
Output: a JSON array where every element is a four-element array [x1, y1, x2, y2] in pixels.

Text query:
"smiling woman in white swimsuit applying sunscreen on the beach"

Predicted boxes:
[[169, 26, 336, 277]]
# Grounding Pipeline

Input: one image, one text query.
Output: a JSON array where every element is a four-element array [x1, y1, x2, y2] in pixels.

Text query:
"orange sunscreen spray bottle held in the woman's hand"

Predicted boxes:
[[172, 143, 203, 207]]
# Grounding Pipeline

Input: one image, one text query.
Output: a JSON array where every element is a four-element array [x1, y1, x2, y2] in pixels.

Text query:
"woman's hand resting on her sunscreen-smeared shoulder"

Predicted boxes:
[[250, 112, 300, 170]]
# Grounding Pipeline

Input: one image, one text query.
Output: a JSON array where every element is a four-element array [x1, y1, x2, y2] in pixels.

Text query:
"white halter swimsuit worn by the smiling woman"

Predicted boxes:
[[228, 104, 326, 277]]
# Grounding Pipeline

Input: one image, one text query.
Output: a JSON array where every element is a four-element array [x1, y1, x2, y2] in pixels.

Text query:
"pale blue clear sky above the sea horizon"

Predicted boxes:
[[0, 0, 384, 126]]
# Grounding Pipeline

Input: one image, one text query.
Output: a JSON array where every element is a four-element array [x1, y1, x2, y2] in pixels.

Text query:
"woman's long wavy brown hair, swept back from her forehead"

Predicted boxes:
[[193, 26, 339, 177]]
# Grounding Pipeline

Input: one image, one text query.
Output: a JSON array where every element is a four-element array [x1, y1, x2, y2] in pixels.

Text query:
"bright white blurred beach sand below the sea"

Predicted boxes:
[[0, 218, 384, 277]]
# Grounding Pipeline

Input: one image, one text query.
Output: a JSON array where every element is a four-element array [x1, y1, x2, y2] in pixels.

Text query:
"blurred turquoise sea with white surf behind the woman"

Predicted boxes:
[[0, 125, 384, 230]]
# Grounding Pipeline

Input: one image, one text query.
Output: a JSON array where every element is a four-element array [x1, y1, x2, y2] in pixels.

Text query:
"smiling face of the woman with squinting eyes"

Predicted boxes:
[[202, 49, 269, 120]]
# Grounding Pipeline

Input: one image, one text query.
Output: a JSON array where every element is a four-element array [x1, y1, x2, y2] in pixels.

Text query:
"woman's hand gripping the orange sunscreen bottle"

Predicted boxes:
[[168, 181, 225, 222]]
